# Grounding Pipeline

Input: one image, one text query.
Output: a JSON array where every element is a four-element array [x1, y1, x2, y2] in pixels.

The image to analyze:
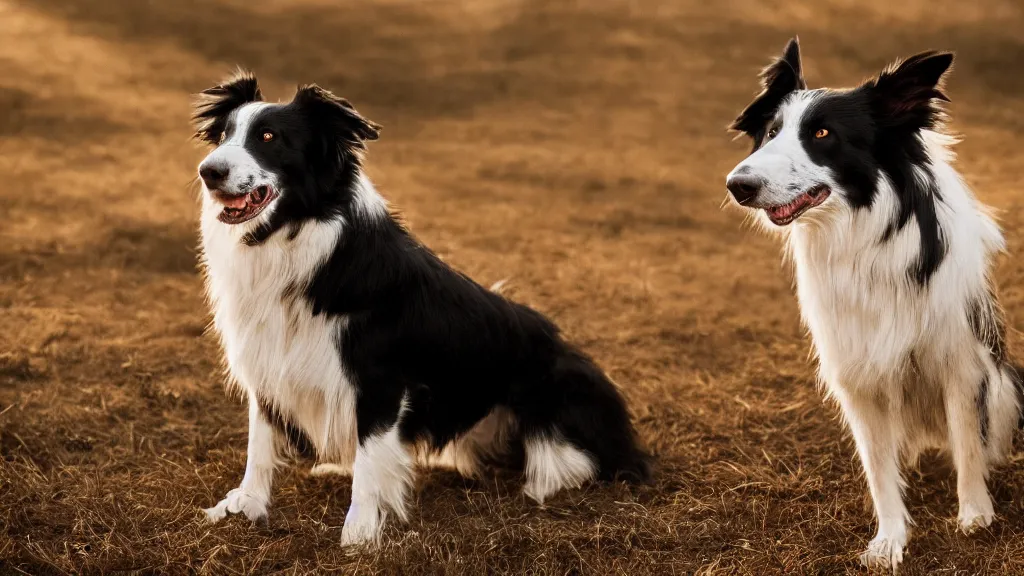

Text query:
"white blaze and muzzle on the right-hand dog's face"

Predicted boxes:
[[726, 91, 835, 208]]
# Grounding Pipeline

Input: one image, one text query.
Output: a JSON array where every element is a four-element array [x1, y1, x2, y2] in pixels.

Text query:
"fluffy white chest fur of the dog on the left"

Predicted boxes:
[[203, 208, 355, 461]]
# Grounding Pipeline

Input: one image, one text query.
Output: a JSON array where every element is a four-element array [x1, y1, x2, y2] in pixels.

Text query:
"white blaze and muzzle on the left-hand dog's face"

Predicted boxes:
[[200, 102, 276, 198]]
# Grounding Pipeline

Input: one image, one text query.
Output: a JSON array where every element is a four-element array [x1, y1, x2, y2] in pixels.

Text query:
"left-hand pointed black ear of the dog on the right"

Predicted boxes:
[[729, 36, 807, 139]]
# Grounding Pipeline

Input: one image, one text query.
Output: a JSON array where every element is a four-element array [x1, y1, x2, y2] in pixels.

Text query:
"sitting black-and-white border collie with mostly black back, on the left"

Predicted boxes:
[[195, 73, 649, 544]]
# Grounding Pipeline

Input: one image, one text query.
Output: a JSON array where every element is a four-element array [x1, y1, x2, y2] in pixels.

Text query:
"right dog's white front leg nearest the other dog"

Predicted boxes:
[[833, 386, 910, 571]]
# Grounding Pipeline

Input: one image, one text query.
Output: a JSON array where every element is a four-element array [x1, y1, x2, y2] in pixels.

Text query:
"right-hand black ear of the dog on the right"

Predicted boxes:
[[865, 51, 953, 130]]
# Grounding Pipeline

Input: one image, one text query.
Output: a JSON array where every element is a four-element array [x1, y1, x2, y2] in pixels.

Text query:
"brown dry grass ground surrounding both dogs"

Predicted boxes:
[[0, 0, 1024, 576]]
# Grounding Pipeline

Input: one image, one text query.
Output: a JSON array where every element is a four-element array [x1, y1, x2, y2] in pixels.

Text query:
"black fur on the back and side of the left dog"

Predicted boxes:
[[319, 213, 647, 479]]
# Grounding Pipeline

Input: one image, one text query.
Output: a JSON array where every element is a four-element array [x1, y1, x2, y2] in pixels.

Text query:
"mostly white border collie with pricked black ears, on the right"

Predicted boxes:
[[726, 38, 1020, 570]]
